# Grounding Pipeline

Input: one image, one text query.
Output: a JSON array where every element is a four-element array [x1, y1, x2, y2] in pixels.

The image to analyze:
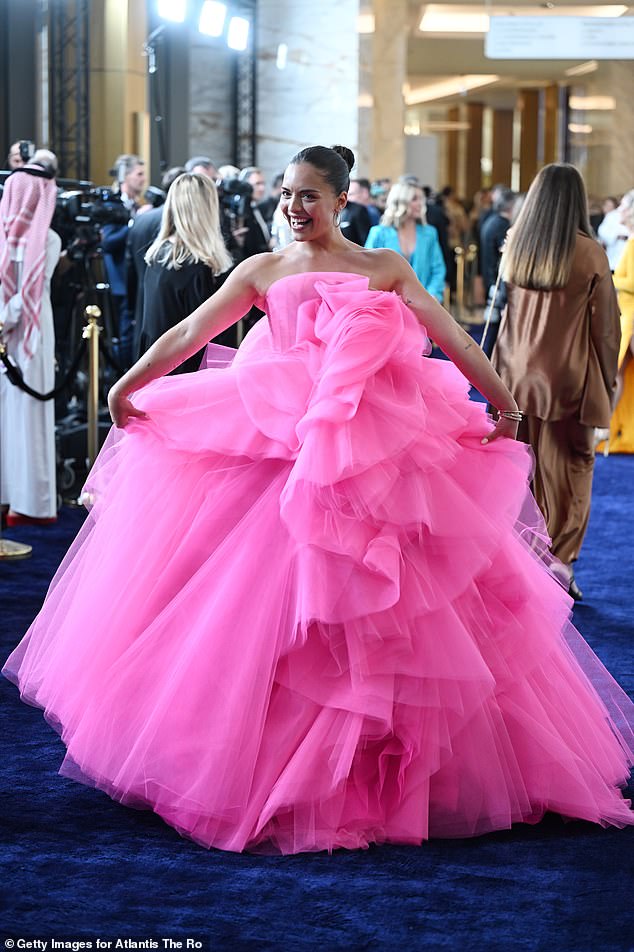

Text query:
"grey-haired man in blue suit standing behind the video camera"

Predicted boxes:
[[101, 155, 145, 368]]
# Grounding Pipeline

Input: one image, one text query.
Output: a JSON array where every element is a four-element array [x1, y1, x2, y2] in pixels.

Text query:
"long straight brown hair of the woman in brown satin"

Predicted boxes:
[[503, 162, 592, 291]]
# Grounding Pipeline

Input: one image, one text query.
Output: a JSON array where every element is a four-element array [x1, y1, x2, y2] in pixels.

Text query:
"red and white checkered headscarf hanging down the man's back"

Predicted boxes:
[[0, 166, 57, 356]]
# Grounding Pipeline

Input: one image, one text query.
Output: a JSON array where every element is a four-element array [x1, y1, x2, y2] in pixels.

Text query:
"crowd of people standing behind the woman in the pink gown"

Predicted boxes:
[[0, 142, 634, 598]]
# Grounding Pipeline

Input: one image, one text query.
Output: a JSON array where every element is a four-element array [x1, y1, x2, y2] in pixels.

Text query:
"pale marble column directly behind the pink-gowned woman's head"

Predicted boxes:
[[256, 0, 359, 180]]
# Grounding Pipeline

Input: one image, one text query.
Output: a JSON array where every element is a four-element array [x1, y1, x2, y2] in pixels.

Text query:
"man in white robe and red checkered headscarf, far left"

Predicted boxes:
[[0, 150, 61, 526]]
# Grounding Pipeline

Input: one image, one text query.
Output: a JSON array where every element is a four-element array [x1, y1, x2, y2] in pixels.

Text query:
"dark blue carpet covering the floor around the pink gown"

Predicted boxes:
[[0, 456, 634, 952]]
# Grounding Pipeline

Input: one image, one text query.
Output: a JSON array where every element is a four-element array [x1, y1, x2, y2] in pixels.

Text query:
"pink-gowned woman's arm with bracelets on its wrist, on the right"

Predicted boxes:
[[390, 256, 518, 442]]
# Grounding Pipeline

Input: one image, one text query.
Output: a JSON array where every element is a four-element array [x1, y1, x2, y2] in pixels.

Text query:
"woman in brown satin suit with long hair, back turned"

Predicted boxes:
[[492, 163, 620, 599]]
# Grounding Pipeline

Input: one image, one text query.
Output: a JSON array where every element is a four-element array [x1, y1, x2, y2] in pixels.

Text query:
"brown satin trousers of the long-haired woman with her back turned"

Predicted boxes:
[[517, 416, 594, 565]]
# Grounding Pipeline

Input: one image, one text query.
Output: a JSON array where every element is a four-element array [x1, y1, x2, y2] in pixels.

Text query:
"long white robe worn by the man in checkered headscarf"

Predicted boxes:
[[0, 229, 61, 519]]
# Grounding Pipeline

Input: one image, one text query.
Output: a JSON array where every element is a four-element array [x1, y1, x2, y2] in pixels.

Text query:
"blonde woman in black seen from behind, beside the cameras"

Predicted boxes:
[[139, 172, 232, 373]]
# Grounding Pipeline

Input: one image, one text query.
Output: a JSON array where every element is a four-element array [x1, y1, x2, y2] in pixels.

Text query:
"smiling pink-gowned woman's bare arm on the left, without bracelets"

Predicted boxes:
[[108, 254, 269, 427]]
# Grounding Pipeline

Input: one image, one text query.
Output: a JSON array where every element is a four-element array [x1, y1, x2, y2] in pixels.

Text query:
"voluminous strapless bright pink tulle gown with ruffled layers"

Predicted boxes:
[[5, 272, 633, 853]]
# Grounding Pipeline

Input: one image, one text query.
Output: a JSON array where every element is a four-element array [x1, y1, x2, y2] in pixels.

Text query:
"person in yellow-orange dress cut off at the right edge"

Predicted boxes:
[[610, 189, 634, 453]]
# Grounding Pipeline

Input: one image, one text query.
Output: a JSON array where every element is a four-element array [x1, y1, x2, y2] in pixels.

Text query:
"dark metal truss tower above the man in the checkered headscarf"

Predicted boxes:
[[48, 0, 90, 179]]
